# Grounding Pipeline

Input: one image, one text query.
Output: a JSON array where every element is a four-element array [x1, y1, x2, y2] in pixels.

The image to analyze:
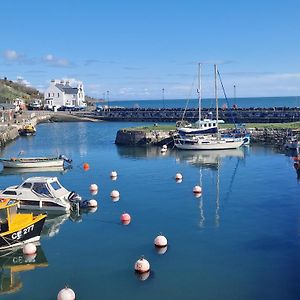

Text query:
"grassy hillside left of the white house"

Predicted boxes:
[[0, 79, 43, 103]]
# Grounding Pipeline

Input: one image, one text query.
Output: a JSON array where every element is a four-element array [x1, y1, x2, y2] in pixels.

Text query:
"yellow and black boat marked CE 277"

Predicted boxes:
[[0, 198, 47, 250]]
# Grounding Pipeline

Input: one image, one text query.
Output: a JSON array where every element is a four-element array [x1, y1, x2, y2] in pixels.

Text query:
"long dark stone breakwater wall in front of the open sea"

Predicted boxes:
[[90, 107, 300, 123]]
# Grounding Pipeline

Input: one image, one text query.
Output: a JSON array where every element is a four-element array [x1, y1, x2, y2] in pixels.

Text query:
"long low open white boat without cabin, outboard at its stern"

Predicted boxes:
[[0, 155, 72, 168]]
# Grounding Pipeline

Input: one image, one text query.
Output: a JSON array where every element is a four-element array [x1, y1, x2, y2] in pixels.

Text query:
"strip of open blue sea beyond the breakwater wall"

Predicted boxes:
[[103, 96, 300, 108]]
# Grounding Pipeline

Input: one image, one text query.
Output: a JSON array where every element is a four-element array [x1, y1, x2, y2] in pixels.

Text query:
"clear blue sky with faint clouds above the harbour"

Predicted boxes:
[[0, 0, 300, 100]]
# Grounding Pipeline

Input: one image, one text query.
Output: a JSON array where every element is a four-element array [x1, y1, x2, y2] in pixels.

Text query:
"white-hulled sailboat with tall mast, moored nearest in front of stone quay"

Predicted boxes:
[[174, 65, 244, 150]]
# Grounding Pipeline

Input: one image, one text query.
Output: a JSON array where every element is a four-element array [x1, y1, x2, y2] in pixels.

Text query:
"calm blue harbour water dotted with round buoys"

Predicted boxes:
[[0, 123, 300, 300]]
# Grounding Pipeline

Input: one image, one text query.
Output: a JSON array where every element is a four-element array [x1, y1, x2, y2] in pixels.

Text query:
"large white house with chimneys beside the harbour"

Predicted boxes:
[[44, 80, 86, 109]]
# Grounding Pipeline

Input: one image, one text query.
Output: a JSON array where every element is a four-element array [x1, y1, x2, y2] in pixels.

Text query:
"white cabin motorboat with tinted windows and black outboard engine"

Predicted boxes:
[[0, 177, 81, 212]]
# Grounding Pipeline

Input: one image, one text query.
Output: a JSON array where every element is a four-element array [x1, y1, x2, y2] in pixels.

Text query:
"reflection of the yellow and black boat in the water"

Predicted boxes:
[[0, 246, 48, 295]]
